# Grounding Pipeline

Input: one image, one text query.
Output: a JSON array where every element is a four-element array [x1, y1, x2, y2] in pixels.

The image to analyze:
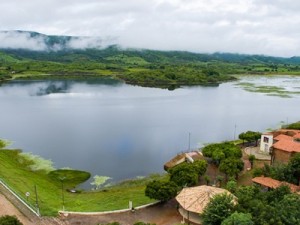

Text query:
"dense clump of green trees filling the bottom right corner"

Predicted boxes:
[[235, 186, 300, 225]]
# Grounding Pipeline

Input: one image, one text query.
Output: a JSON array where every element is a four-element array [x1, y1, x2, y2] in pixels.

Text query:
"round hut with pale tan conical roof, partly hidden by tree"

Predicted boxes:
[[176, 185, 237, 224]]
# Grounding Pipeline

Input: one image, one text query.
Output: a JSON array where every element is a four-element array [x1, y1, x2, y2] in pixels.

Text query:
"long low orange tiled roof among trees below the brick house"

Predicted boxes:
[[252, 177, 300, 193]]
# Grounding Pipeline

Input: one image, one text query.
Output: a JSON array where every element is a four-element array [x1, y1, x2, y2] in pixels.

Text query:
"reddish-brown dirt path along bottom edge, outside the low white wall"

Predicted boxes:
[[0, 191, 181, 225]]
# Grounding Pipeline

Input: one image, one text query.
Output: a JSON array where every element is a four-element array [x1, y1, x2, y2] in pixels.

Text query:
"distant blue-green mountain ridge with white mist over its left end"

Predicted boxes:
[[0, 30, 300, 64]]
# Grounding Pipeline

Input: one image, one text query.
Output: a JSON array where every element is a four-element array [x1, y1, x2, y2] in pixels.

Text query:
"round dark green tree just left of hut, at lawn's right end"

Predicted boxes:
[[145, 180, 178, 201]]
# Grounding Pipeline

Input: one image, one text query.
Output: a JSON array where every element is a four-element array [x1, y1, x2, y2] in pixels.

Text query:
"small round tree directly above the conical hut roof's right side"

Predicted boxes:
[[219, 158, 244, 177]]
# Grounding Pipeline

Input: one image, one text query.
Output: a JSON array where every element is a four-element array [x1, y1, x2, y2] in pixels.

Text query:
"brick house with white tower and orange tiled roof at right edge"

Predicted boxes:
[[260, 129, 300, 164]]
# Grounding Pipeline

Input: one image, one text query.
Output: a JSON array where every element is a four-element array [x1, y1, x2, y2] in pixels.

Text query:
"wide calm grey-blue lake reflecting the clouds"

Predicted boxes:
[[0, 76, 300, 185]]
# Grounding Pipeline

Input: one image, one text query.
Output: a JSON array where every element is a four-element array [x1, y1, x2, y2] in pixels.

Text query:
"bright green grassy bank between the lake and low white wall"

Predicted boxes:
[[0, 150, 153, 216]]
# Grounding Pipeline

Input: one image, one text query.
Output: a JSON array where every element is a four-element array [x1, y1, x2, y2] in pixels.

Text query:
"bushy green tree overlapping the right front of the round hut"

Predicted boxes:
[[202, 194, 235, 225]]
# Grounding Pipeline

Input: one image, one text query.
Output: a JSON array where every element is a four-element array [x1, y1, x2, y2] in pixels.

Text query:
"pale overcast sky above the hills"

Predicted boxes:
[[0, 0, 300, 57]]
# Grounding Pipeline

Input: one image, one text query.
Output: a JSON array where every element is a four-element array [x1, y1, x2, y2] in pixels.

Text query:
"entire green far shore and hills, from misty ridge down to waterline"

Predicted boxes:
[[0, 31, 300, 88]]
